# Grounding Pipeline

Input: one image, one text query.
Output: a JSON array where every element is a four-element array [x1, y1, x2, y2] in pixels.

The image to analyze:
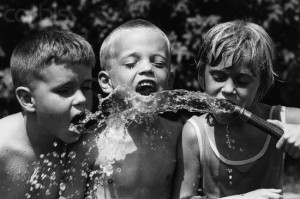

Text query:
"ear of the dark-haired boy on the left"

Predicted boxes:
[[16, 86, 35, 112]]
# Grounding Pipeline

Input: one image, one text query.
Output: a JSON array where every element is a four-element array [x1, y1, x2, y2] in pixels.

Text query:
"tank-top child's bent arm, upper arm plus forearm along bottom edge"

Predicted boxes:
[[173, 122, 282, 199]]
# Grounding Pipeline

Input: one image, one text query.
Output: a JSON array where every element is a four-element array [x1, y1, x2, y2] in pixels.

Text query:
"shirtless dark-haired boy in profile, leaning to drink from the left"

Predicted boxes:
[[0, 31, 95, 199]]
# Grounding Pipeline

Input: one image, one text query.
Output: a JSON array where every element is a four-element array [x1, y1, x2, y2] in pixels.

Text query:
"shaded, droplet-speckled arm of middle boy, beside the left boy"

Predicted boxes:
[[60, 135, 95, 199]]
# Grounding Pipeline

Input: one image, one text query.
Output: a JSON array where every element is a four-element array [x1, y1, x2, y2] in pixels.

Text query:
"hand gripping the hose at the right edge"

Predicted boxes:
[[268, 107, 300, 158]]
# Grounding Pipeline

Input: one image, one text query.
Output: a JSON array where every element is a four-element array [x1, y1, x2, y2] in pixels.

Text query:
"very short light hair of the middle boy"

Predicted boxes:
[[99, 19, 171, 71]]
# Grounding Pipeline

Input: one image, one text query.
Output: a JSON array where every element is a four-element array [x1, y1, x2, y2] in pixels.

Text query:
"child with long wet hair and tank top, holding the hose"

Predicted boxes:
[[175, 20, 300, 199]]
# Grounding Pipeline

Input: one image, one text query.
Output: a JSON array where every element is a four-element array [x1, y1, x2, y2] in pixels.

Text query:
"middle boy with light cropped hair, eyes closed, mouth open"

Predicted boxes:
[[62, 20, 181, 199]]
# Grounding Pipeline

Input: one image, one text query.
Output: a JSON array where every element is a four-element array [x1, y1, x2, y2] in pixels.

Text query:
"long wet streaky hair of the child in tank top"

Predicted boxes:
[[197, 20, 275, 101]]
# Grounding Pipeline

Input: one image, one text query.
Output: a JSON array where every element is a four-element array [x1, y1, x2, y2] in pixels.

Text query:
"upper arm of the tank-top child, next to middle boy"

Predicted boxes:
[[173, 122, 201, 199]]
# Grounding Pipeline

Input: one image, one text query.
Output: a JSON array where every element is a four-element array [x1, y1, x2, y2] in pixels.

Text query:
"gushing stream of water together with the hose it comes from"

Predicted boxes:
[[70, 87, 283, 139]]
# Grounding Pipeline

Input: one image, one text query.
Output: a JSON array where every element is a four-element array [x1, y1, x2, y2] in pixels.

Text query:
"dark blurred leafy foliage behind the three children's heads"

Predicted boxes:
[[0, 0, 300, 193]]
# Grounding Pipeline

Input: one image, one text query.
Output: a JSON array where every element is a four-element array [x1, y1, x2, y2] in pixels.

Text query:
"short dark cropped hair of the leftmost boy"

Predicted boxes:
[[10, 30, 95, 88]]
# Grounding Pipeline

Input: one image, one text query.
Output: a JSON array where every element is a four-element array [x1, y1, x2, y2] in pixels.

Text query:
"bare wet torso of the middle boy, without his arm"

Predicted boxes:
[[86, 118, 181, 199]]
